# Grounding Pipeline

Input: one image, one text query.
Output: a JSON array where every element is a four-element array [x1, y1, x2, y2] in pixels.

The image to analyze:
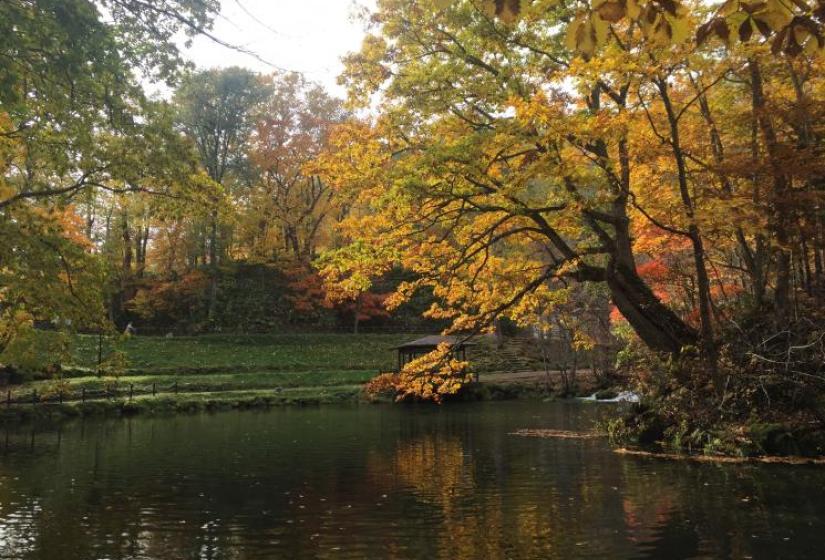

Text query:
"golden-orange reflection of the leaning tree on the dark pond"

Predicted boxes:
[[382, 434, 630, 559]]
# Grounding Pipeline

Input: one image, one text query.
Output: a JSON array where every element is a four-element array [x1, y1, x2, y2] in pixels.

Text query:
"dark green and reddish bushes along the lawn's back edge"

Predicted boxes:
[[110, 262, 446, 335]]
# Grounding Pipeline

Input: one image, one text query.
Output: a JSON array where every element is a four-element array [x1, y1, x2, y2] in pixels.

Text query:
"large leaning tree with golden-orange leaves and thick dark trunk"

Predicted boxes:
[[322, 2, 696, 352]]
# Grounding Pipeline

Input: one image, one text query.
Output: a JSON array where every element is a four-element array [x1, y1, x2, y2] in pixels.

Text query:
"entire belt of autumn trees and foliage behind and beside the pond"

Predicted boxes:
[[0, 0, 825, 406]]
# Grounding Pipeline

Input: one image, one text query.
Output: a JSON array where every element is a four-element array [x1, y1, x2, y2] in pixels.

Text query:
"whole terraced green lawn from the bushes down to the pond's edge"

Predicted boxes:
[[0, 332, 568, 419]]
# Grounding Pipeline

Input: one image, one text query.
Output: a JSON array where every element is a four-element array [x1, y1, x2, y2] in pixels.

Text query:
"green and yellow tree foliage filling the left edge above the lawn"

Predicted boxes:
[[0, 0, 218, 363]]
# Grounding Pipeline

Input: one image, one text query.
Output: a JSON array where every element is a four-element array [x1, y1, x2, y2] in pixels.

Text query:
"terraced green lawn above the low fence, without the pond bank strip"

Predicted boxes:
[[3, 332, 424, 402]]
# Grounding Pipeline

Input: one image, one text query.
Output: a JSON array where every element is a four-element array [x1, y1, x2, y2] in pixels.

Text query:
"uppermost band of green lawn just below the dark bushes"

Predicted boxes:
[[64, 334, 415, 373]]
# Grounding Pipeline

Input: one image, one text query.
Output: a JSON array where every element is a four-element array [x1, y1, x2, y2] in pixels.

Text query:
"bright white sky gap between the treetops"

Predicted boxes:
[[179, 0, 374, 97]]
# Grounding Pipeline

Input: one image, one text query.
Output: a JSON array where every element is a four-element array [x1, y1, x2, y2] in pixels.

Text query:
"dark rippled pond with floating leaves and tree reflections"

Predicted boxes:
[[0, 402, 825, 560]]
